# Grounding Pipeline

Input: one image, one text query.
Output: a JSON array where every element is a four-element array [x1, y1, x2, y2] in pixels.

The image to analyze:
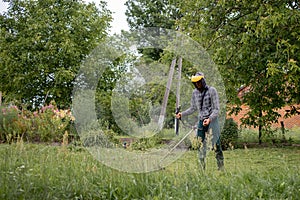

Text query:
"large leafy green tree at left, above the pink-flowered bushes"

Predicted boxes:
[[0, 0, 111, 107]]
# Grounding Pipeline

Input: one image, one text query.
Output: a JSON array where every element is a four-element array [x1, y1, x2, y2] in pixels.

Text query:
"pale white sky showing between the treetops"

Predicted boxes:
[[0, 0, 129, 35]]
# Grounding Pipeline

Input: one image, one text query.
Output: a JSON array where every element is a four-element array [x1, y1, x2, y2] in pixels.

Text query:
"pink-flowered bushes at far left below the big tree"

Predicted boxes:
[[0, 102, 77, 143]]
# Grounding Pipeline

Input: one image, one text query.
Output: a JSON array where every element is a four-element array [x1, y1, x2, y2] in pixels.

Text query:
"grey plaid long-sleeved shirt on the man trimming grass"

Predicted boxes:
[[181, 87, 220, 121]]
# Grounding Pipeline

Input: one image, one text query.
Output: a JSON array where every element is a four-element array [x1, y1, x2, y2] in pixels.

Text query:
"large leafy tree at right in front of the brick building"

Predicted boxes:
[[180, 0, 300, 142]]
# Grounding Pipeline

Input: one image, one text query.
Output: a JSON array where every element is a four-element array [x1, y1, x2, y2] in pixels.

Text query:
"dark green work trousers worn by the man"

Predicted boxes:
[[197, 119, 224, 169]]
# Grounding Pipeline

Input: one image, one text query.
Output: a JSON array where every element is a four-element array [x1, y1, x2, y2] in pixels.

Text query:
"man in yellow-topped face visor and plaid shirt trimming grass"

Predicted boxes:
[[176, 72, 224, 170]]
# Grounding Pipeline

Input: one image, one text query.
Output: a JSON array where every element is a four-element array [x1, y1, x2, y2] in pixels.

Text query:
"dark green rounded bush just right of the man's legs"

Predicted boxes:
[[221, 118, 239, 150]]
